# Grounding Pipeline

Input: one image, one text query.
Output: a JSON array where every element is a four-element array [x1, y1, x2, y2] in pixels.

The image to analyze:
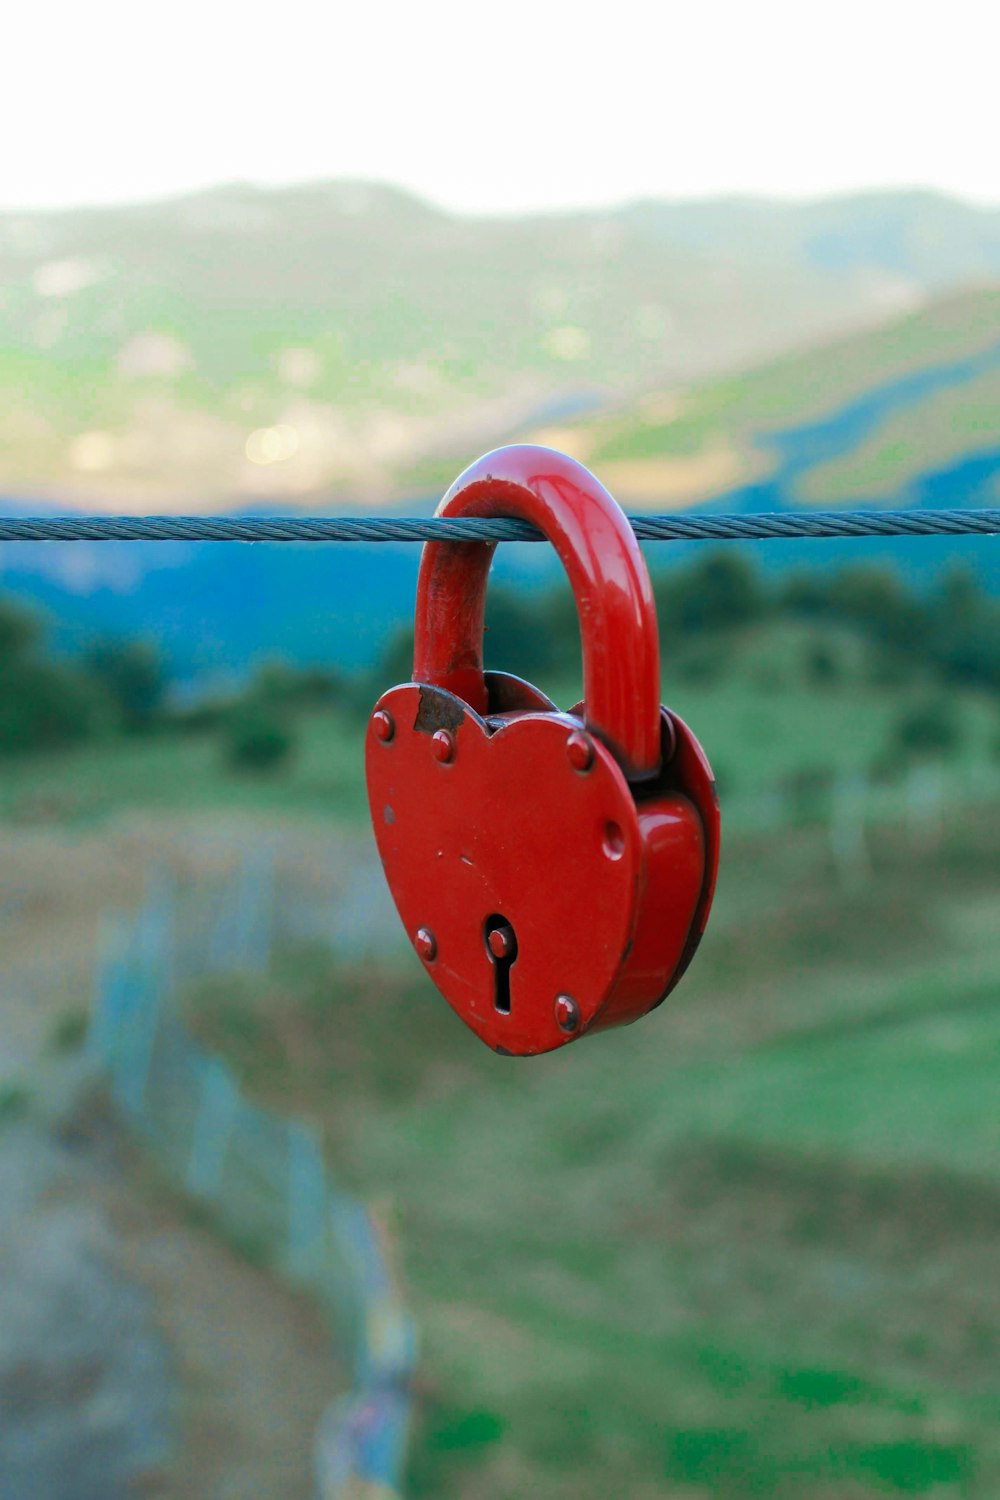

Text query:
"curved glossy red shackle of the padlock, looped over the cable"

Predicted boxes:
[[414, 444, 660, 780]]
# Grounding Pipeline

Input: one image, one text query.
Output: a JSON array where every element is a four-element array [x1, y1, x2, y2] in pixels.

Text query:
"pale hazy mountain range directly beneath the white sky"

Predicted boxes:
[[0, 183, 1000, 510]]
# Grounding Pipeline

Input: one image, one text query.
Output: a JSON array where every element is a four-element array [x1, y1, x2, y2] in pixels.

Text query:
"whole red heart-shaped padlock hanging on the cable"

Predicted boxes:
[[366, 446, 720, 1056]]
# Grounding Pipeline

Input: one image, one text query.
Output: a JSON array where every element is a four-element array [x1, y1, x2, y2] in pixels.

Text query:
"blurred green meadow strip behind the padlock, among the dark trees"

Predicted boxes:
[[0, 624, 1000, 828]]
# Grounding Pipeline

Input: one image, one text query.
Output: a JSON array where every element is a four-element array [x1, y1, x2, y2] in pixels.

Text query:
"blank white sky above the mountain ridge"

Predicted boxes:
[[0, 0, 1000, 212]]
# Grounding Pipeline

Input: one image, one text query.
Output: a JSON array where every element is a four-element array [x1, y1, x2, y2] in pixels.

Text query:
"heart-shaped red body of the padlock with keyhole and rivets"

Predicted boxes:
[[366, 678, 718, 1056]]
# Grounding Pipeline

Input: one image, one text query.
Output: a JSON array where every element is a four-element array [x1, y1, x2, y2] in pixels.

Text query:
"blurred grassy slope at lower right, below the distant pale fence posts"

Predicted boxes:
[[185, 815, 1000, 1500]]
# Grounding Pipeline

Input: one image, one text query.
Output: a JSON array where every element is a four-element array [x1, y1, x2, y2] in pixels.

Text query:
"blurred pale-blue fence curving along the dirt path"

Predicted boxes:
[[87, 851, 415, 1500]]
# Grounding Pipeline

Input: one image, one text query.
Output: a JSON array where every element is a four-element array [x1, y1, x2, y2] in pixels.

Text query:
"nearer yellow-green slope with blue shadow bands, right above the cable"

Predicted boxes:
[[532, 284, 1000, 510]]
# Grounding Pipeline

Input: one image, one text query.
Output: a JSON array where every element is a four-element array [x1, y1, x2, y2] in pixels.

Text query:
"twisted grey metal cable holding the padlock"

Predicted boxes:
[[0, 510, 1000, 542]]
